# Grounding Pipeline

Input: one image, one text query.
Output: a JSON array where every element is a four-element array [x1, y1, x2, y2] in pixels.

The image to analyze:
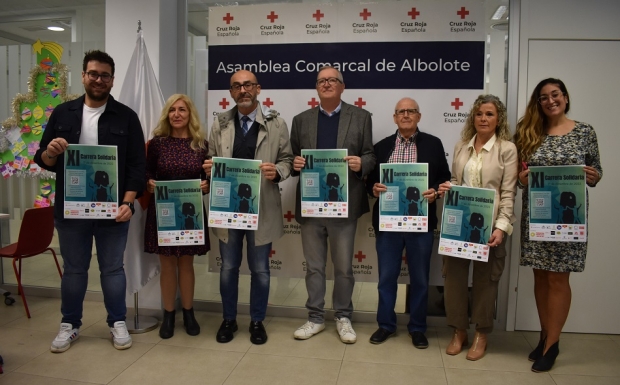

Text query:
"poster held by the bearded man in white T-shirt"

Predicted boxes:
[[64, 144, 119, 219]]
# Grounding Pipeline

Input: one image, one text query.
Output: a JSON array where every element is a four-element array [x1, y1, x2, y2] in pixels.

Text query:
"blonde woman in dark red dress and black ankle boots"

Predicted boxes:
[[144, 94, 209, 338]]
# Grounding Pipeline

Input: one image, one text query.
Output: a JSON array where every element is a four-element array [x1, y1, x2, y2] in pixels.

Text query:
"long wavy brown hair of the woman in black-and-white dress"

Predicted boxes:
[[514, 78, 570, 162]]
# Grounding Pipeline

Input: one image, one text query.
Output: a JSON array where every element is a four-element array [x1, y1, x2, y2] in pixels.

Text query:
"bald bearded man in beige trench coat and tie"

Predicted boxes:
[[203, 70, 293, 345]]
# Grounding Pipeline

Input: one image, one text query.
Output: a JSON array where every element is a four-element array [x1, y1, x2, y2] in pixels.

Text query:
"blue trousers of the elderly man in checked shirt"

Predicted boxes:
[[376, 231, 433, 333]]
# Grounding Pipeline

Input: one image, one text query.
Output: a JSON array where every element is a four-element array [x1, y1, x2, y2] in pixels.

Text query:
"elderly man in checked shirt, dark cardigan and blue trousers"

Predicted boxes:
[[366, 98, 450, 349]]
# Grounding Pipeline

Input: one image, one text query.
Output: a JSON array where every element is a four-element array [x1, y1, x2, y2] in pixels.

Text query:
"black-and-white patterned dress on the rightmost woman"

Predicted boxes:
[[520, 121, 603, 272]]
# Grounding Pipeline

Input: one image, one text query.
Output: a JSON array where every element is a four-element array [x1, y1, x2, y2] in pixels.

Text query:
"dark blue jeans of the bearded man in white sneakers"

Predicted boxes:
[[54, 219, 129, 328]]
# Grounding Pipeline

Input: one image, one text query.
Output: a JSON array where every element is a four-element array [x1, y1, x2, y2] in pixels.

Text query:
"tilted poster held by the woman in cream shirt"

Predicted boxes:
[[439, 186, 495, 262]]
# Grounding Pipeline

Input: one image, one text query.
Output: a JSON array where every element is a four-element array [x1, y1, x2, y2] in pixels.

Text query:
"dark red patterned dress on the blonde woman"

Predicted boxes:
[[144, 136, 210, 257]]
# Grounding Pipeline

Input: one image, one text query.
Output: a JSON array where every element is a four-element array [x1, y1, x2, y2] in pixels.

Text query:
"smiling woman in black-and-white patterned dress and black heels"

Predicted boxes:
[[514, 78, 603, 372]]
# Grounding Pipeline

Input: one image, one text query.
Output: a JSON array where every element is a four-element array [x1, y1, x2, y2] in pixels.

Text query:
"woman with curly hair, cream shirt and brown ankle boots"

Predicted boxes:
[[439, 95, 517, 361]]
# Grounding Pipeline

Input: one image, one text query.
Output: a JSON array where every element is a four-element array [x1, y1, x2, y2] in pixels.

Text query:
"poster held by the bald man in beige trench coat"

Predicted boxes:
[[209, 157, 261, 230]]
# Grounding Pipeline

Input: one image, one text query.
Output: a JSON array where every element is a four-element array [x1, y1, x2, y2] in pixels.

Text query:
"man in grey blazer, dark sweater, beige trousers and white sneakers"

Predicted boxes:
[[291, 66, 375, 343]]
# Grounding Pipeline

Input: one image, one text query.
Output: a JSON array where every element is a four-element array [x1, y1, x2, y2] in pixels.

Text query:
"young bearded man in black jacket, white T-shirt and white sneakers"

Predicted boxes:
[[35, 51, 146, 353]]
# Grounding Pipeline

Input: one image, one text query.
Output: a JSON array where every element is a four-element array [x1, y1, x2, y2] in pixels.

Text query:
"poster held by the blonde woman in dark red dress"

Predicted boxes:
[[155, 179, 205, 246]]
